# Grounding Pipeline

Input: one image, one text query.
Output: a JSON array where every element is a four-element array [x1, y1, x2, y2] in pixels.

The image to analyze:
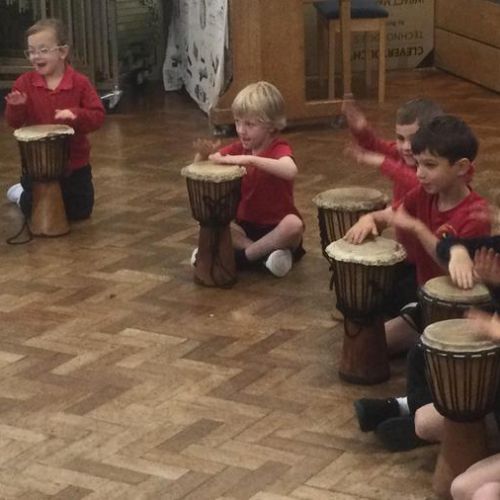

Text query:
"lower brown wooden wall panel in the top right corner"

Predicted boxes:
[[435, 28, 500, 92]]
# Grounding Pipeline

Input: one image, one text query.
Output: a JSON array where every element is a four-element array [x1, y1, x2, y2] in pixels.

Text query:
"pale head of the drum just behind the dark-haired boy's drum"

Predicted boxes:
[[313, 186, 387, 212]]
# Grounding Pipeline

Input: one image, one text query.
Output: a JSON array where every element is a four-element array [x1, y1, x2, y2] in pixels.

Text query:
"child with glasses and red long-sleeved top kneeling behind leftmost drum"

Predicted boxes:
[[5, 19, 105, 220]]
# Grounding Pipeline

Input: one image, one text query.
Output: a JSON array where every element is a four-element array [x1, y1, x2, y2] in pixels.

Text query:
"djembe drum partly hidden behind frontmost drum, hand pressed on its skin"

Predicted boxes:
[[418, 276, 492, 327]]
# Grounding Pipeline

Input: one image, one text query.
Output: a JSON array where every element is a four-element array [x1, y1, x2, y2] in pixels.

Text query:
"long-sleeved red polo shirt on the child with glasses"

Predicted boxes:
[[5, 65, 105, 170]]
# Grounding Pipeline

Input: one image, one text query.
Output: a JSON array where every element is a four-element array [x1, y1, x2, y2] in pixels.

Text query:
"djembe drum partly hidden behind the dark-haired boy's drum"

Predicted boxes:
[[313, 186, 387, 261]]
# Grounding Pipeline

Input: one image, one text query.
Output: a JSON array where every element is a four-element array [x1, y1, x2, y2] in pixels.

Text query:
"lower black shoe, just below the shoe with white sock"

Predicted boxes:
[[375, 415, 431, 451]]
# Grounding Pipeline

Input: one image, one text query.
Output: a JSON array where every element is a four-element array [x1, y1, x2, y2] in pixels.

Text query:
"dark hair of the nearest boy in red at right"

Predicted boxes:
[[411, 115, 479, 165]]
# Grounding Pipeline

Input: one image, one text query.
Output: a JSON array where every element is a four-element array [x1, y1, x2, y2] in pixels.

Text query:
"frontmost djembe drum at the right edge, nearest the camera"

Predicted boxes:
[[420, 319, 500, 498]]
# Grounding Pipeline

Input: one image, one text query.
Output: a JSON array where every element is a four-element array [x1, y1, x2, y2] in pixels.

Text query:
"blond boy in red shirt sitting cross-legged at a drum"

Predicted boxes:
[[196, 82, 305, 277]]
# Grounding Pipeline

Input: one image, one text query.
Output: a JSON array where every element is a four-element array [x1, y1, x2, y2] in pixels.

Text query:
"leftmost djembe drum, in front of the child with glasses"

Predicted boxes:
[[14, 125, 75, 236]]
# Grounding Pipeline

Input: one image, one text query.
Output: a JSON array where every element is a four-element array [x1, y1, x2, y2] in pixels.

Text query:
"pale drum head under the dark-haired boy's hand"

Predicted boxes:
[[325, 236, 406, 266]]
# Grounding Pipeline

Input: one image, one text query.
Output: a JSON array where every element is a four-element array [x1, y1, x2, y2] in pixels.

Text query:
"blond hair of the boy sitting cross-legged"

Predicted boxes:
[[231, 82, 286, 130]]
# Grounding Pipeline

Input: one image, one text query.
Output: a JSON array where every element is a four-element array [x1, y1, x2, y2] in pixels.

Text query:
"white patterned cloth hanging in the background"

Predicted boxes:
[[163, 0, 228, 113]]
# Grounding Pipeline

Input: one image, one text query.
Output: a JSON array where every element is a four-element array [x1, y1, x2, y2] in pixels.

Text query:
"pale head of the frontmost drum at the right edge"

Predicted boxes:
[[421, 319, 500, 354]]
